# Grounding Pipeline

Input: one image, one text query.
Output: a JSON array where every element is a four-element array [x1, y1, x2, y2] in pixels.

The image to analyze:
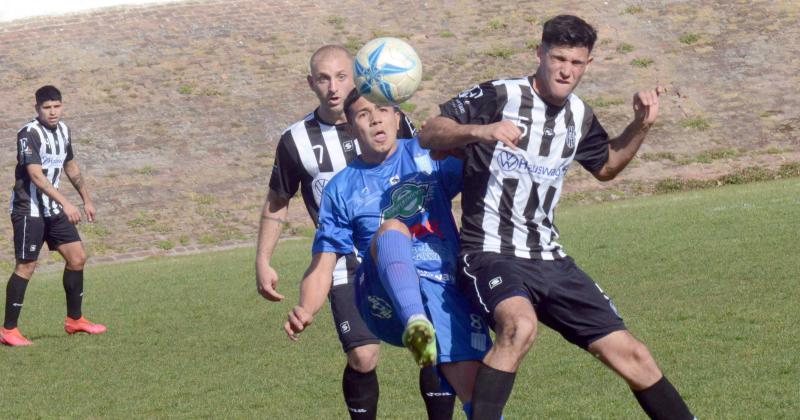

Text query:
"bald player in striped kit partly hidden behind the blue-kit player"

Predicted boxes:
[[256, 45, 455, 419]]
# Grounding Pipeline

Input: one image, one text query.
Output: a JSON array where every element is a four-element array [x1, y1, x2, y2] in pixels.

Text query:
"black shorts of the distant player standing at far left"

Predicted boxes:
[[11, 212, 81, 261]]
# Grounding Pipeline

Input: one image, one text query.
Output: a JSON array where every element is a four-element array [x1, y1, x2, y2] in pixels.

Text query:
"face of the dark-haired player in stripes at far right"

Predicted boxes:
[[534, 45, 592, 105]]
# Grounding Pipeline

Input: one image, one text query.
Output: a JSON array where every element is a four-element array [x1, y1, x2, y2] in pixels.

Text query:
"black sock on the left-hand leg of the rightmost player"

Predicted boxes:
[[472, 363, 517, 420]]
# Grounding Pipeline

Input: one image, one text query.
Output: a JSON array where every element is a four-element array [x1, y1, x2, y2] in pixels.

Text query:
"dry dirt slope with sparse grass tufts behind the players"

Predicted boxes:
[[0, 0, 800, 268]]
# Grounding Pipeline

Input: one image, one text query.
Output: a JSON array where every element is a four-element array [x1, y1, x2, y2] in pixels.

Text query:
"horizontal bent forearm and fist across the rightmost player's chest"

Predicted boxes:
[[419, 116, 522, 150]]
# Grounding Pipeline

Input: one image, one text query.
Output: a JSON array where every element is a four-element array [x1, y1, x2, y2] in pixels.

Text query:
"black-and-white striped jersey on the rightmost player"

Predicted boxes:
[[440, 78, 608, 260]]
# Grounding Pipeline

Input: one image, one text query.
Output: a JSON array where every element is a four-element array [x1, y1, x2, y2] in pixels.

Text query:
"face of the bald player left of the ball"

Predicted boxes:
[[308, 52, 354, 118]]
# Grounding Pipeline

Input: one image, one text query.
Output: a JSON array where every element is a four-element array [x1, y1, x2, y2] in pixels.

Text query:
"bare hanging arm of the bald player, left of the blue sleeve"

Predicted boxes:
[[256, 190, 289, 302]]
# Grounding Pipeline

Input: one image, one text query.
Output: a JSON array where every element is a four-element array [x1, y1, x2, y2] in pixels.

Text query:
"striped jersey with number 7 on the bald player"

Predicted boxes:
[[269, 110, 416, 226]]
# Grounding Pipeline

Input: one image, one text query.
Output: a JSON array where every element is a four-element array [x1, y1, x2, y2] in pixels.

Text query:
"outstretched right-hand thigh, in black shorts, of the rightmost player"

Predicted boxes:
[[536, 257, 625, 349]]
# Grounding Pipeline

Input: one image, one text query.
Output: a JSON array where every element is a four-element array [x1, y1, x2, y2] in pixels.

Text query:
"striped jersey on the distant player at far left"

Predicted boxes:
[[9, 119, 72, 217]]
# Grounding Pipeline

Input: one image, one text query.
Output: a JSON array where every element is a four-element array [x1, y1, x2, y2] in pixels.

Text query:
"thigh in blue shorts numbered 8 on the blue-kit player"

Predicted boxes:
[[420, 277, 491, 363]]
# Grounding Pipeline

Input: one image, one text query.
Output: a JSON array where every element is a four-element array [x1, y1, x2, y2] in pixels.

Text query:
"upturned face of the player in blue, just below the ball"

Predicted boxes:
[[350, 97, 400, 163]]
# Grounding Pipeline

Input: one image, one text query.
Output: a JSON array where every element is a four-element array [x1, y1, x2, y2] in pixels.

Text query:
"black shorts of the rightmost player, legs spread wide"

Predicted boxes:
[[458, 252, 625, 349]]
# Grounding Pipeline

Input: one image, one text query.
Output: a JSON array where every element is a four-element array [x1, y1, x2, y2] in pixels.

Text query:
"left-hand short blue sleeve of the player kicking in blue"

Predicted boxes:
[[312, 184, 353, 254]]
